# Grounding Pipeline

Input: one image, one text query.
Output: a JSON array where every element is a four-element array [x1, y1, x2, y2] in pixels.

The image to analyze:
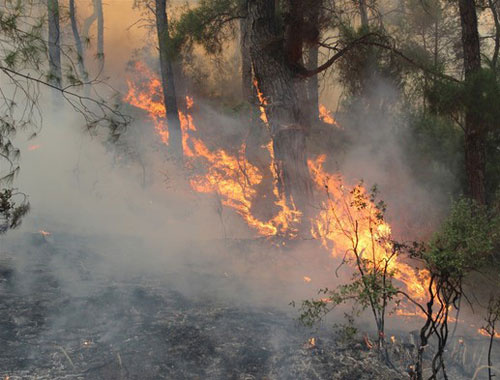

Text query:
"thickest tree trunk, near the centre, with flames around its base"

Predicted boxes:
[[248, 0, 311, 209]]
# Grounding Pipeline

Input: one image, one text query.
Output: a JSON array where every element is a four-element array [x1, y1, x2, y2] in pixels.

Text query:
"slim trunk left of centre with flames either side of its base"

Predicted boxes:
[[155, 0, 183, 160]]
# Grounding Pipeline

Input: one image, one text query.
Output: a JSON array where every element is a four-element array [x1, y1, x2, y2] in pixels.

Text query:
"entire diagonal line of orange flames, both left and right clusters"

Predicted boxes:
[[125, 60, 428, 308]]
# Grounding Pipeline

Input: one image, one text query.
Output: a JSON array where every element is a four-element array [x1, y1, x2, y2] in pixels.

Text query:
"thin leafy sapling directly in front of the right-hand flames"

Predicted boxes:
[[299, 184, 402, 362]]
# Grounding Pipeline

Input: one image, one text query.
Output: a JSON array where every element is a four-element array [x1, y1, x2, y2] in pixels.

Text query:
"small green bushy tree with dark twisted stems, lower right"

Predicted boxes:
[[400, 198, 498, 380]]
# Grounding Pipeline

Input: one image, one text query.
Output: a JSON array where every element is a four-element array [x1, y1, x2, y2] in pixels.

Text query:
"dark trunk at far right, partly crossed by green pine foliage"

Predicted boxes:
[[458, 0, 486, 204]]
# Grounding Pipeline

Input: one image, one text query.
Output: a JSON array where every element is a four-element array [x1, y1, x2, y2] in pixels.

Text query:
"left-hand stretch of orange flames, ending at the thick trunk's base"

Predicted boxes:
[[125, 63, 301, 237]]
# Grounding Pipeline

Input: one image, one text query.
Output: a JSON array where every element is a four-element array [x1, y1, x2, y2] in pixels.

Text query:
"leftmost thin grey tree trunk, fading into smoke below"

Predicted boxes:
[[47, 0, 62, 87]]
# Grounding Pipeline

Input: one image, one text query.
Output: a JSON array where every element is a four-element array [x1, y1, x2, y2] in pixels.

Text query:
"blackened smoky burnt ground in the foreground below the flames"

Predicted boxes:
[[0, 234, 492, 380]]
